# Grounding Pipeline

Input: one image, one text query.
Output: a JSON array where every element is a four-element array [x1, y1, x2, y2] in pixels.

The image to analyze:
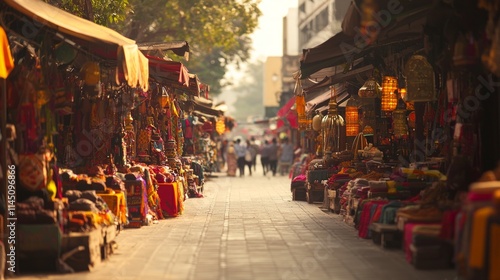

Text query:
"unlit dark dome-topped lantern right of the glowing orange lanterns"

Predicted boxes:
[[405, 55, 436, 102]]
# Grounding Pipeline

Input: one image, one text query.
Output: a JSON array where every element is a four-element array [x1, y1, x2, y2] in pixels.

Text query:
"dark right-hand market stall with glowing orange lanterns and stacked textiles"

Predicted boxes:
[[292, 1, 500, 279]]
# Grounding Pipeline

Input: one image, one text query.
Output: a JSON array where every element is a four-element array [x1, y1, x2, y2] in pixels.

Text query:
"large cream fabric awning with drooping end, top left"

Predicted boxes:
[[4, 0, 149, 90]]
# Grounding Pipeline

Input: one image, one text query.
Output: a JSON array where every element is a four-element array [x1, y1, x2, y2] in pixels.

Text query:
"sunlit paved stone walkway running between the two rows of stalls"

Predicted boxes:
[[16, 169, 455, 280]]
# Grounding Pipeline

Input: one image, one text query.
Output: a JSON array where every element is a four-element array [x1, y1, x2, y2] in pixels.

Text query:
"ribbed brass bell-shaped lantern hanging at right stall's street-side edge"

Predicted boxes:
[[321, 86, 344, 155]]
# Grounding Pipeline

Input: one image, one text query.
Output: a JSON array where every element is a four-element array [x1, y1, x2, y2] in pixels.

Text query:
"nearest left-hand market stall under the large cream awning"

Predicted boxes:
[[0, 0, 154, 273]]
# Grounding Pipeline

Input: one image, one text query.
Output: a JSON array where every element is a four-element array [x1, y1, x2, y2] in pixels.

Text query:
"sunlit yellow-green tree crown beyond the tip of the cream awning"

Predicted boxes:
[[116, 0, 261, 95]]
